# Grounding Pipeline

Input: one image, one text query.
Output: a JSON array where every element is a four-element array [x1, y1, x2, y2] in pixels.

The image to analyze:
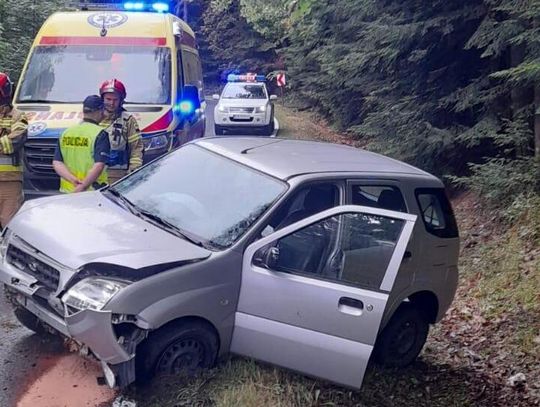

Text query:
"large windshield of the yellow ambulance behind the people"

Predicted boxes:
[[17, 45, 171, 104]]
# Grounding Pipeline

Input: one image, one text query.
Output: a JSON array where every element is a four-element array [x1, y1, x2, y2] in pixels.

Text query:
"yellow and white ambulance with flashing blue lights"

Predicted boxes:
[[14, 2, 206, 198]]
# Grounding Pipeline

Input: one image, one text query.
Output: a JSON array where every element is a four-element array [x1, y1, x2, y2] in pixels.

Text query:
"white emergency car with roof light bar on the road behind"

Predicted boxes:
[[213, 75, 277, 136]]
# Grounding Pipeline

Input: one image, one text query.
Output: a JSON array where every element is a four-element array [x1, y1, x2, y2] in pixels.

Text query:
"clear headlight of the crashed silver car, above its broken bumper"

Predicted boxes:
[[62, 277, 128, 310]]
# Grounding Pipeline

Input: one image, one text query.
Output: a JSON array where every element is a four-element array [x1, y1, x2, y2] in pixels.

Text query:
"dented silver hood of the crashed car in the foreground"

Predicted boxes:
[[8, 191, 211, 269]]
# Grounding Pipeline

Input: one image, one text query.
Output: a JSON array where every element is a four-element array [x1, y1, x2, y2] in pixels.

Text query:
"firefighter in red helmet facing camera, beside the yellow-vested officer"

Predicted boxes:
[[99, 79, 143, 183]]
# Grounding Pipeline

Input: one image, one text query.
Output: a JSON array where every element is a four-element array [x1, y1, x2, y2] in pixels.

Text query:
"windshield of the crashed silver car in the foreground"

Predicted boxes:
[[112, 145, 286, 250]]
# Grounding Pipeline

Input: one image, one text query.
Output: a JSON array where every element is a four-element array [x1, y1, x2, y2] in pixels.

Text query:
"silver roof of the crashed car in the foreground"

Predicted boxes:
[[195, 137, 437, 180]]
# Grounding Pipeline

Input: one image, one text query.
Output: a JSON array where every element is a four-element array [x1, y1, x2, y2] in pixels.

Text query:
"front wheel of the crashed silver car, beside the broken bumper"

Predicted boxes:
[[137, 321, 219, 383]]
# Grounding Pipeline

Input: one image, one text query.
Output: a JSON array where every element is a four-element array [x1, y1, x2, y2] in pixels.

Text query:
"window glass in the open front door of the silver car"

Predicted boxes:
[[254, 213, 404, 290]]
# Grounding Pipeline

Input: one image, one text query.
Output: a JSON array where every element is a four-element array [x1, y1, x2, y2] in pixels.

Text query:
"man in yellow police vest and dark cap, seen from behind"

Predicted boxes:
[[53, 95, 111, 192]]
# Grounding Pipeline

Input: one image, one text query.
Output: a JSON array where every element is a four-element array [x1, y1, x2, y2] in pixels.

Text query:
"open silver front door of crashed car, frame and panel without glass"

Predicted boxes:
[[231, 205, 416, 388]]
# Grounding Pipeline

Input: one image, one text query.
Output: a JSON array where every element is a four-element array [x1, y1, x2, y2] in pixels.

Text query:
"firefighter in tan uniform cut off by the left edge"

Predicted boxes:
[[0, 72, 28, 228]]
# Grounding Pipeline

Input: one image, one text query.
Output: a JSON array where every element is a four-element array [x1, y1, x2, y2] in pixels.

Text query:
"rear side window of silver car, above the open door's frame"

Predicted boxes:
[[351, 184, 407, 212]]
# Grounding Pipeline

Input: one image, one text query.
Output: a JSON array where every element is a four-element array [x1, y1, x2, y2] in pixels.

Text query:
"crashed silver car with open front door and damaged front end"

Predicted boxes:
[[0, 137, 459, 388]]
